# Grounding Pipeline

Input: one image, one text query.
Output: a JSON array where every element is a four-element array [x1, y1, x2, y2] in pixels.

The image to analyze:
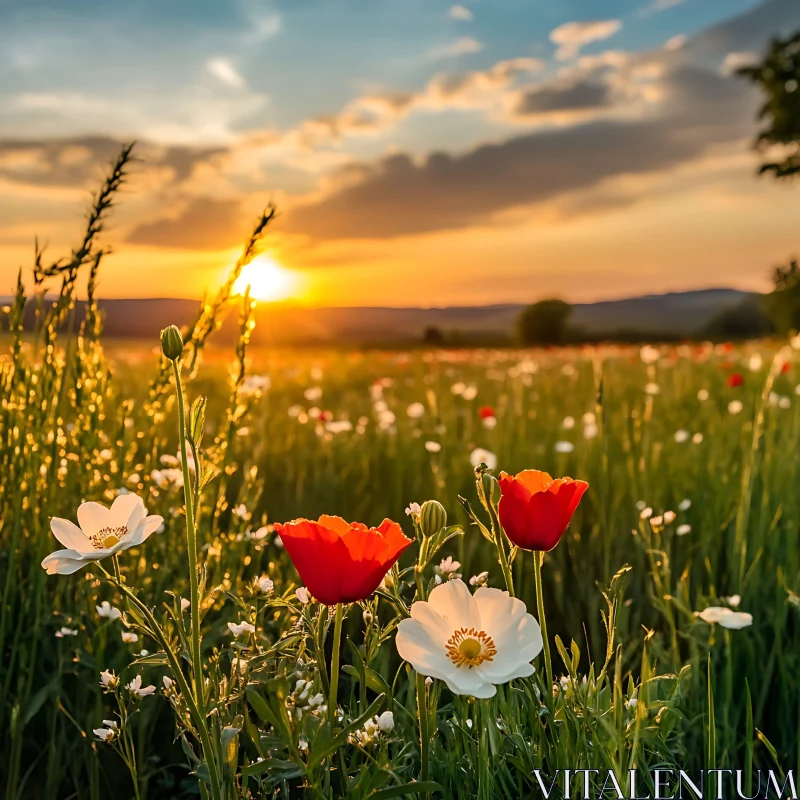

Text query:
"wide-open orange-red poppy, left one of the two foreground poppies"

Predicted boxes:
[[275, 514, 412, 606]]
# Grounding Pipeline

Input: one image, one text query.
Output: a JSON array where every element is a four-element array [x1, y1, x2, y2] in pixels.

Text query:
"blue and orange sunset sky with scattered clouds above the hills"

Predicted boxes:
[[0, 0, 800, 306]]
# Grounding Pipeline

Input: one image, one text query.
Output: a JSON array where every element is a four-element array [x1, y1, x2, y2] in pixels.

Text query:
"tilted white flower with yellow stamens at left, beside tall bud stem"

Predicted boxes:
[[42, 494, 164, 575]]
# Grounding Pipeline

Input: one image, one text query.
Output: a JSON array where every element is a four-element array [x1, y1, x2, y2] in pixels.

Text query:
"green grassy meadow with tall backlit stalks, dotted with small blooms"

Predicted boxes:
[[0, 152, 800, 800]]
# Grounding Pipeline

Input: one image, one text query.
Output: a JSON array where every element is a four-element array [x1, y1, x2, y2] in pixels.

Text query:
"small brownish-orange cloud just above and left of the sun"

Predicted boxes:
[[127, 197, 246, 250]]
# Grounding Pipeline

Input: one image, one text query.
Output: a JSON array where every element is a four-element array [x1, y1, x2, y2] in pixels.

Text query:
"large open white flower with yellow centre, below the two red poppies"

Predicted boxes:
[[396, 580, 542, 697]]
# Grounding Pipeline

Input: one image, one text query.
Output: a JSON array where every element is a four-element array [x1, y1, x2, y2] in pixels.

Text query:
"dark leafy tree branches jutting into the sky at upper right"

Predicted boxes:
[[737, 31, 800, 178]]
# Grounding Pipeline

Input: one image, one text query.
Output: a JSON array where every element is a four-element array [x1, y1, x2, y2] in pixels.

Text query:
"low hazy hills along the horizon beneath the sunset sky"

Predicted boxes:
[[6, 289, 748, 344]]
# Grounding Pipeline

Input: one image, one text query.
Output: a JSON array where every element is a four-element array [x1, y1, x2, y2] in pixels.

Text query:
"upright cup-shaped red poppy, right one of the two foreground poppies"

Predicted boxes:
[[499, 469, 589, 552]]
